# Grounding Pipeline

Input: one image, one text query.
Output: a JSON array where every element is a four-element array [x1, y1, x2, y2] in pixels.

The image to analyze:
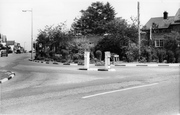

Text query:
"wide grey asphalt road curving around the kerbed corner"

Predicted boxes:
[[0, 54, 180, 115]]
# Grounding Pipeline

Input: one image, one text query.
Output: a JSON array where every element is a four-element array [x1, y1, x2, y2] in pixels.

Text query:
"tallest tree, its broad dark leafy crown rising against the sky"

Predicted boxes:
[[72, 2, 116, 35]]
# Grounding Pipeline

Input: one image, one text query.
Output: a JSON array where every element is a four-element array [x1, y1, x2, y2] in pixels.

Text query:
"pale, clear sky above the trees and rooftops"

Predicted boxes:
[[0, 0, 180, 50]]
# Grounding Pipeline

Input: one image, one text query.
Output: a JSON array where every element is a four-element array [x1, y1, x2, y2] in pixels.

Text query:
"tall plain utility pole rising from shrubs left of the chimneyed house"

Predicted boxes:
[[137, 2, 141, 58]]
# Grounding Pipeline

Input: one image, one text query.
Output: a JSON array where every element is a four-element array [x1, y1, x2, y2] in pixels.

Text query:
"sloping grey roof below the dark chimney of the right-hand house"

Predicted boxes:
[[144, 16, 174, 30]]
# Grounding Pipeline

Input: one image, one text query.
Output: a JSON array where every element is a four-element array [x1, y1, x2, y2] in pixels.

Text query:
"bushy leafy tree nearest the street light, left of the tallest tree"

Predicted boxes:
[[37, 23, 72, 57]]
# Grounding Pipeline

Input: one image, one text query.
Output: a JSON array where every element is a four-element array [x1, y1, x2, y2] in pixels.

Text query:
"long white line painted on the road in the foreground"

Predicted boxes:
[[82, 83, 159, 99]]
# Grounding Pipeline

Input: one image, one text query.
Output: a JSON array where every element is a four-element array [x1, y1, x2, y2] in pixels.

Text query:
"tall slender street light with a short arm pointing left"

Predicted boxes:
[[22, 9, 33, 60]]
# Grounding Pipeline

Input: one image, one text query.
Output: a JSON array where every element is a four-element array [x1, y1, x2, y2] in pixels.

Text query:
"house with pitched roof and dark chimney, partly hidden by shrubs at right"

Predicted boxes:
[[142, 8, 180, 47]]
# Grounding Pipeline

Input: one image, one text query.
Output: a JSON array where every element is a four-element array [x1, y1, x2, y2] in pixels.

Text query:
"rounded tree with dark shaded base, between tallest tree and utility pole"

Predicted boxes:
[[96, 18, 138, 58]]
